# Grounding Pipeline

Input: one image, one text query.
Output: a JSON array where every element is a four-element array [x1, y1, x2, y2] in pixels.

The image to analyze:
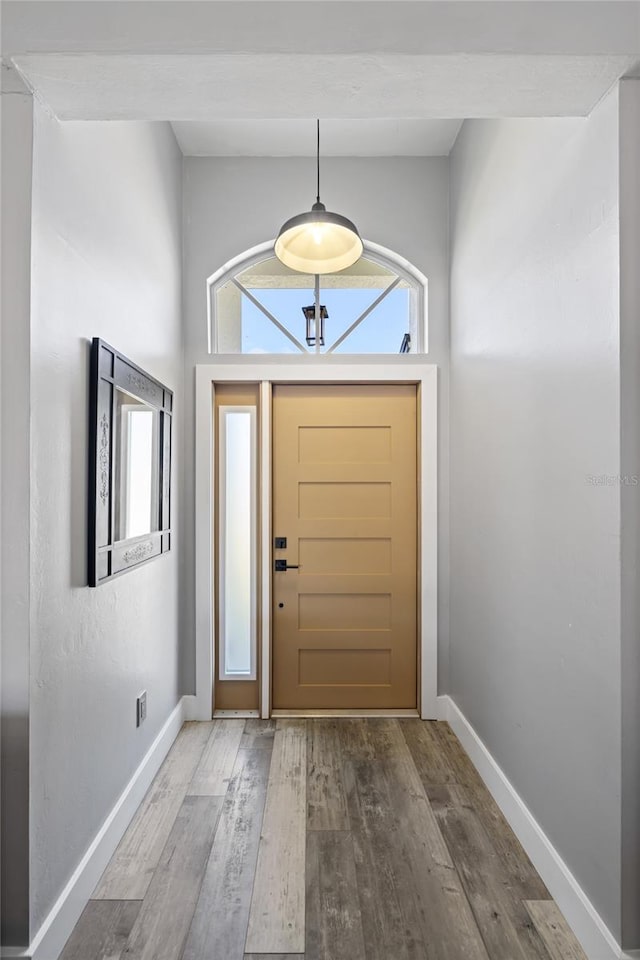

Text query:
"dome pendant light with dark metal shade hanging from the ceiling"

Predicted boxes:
[[275, 120, 363, 274]]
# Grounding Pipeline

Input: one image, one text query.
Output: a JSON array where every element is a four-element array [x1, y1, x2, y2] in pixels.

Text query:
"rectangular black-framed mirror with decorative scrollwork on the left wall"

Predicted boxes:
[[89, 337, 173, 587]]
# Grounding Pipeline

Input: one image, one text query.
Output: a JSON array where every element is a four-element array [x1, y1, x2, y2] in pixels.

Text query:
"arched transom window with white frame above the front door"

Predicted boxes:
[[207, 242, 427, 356]]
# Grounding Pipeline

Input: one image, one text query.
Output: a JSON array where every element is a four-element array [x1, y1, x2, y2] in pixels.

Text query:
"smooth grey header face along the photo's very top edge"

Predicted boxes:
[[6, 0, 640, 57]]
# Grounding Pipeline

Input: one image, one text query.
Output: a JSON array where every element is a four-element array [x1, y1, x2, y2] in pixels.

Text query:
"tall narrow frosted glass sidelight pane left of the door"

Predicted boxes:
[[220, 406, 256, 680]]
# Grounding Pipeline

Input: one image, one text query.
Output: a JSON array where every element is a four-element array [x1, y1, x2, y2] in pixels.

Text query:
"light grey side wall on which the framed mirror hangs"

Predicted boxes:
[[31, 109, 183, 934]]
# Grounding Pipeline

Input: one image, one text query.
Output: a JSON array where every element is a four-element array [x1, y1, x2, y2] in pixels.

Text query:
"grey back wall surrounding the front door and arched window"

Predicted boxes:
[[184, 158, 449, 692]]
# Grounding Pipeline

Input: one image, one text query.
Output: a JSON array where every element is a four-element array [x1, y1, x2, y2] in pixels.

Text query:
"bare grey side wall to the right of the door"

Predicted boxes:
[[450, 94, 621, 939]]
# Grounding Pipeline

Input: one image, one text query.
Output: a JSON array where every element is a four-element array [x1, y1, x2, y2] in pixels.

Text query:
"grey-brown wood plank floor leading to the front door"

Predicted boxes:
[[60, 718, 586, 960]]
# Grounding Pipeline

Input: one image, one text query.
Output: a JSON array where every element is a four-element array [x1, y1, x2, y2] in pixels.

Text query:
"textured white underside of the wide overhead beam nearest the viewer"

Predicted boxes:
[[13, 53, 634, 121]]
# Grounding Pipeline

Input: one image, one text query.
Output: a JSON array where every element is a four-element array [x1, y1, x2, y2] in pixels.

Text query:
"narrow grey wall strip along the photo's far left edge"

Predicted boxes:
[[0, 80, 33, 943]]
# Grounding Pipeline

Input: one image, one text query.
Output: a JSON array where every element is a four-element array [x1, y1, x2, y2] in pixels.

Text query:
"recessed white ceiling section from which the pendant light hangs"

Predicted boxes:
[[173, 119, 462, 157]]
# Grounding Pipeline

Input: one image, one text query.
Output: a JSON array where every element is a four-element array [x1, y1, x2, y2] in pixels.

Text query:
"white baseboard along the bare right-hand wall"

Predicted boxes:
[[438, 696, 634, 960]]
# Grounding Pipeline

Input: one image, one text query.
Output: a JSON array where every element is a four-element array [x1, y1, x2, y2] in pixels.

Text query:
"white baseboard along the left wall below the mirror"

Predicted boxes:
[[0, 697, 194, 960]]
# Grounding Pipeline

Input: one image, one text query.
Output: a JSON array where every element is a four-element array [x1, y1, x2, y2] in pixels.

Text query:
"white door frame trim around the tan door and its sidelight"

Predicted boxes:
[[193, 355, 438, 720]]
